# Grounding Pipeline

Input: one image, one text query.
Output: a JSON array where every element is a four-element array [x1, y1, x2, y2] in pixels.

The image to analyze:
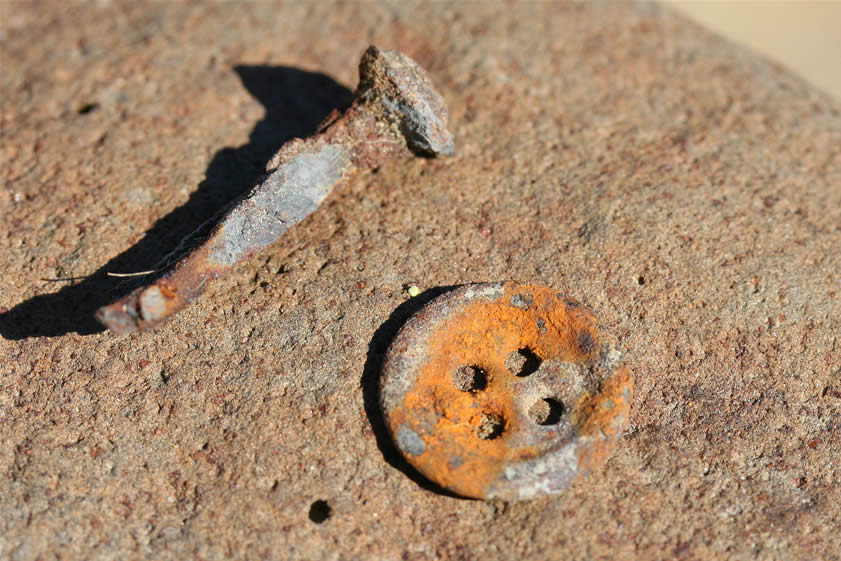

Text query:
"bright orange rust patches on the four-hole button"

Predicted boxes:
[[383, 283, 632, 498]]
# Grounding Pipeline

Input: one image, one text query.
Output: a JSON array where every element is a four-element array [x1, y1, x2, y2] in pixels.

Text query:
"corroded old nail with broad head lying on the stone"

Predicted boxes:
[[96, 46, 455, 333]]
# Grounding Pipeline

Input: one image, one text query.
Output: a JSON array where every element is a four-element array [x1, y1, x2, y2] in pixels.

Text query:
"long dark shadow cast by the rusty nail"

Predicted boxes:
[[0, 65, 353, 339]]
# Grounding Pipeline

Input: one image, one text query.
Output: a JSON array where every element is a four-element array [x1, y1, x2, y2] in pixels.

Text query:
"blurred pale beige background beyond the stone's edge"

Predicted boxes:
[[664, 0, 841, 100]]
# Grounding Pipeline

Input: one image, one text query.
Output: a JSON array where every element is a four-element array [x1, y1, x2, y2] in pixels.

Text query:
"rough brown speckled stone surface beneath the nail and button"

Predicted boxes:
[[0, 0, 841, 561]]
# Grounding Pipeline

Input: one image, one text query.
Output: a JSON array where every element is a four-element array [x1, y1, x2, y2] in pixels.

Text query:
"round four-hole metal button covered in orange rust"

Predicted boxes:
[[380, 283, 633, 500]]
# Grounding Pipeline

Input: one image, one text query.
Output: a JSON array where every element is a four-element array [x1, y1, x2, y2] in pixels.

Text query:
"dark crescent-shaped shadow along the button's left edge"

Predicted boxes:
[[360, 285, 466, 500]]
